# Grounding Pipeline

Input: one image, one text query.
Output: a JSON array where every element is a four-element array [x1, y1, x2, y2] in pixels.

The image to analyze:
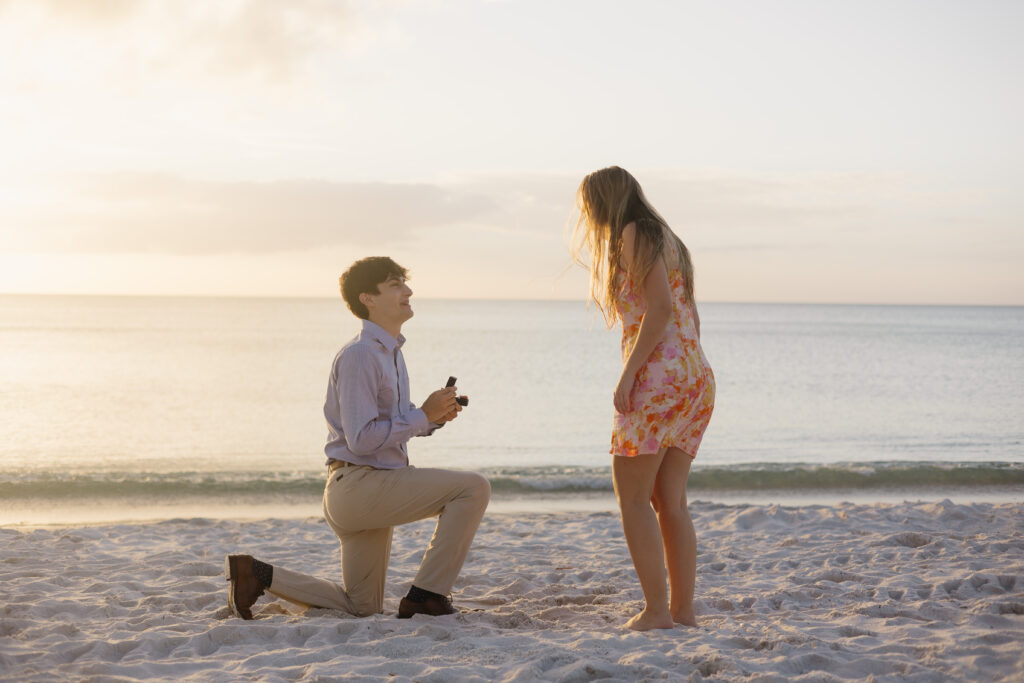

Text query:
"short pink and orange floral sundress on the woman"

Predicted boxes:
[[610, 247, 715, 459]]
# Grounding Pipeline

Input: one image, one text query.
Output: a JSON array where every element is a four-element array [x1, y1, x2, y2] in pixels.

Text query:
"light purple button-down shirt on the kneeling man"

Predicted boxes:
[[324, 321, 437, 470]]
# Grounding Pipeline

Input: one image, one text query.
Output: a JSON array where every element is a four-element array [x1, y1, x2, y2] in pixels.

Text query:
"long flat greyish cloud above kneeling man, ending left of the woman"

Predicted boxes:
[[0, 173, 494, 254]]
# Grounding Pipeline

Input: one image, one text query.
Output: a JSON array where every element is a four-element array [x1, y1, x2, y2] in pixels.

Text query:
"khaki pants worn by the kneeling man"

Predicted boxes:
[[269, 466, 490, 616]]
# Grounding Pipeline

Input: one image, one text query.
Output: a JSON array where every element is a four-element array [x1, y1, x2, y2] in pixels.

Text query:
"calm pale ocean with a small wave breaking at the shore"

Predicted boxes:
[[0, 296, 1024, 524]]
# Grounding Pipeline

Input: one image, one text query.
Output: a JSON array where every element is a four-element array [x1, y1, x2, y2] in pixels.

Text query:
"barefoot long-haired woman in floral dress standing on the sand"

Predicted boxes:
[[572, 166, 715, 631]]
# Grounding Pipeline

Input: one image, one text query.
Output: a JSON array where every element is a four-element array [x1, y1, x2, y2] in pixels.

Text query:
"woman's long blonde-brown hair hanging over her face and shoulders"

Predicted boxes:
[[570, 166, 693, 327]]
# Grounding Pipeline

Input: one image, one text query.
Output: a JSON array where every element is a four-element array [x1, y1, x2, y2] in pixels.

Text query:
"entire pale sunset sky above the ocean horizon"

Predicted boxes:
[[0, 0, 1024, 305]]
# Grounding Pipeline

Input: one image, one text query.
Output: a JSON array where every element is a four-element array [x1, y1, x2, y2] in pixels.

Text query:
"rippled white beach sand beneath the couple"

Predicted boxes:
[[0, 502, 1024, 682]]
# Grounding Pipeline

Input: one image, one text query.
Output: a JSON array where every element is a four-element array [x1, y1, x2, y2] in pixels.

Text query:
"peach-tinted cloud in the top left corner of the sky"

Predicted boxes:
[[0, 0, 369, 87]]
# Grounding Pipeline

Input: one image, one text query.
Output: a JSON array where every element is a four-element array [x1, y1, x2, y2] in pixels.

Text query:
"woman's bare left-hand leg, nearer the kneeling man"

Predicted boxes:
[[611, 454, 674, 631]]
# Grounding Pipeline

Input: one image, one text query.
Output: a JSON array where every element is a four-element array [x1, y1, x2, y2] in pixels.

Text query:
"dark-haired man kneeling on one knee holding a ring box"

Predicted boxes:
[[225, 257, 490, 620]]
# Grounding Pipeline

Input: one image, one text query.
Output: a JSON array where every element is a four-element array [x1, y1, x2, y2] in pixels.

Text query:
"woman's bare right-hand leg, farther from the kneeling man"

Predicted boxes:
[[652, 449, 697, 626]]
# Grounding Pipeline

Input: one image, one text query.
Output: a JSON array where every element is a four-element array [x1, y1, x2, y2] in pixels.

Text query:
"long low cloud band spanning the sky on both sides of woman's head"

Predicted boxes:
[[0, 166, 1007, 266]]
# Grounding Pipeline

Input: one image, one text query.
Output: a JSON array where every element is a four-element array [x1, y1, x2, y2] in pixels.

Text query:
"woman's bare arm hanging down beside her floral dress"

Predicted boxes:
[[614, 223, 672, 413]]
